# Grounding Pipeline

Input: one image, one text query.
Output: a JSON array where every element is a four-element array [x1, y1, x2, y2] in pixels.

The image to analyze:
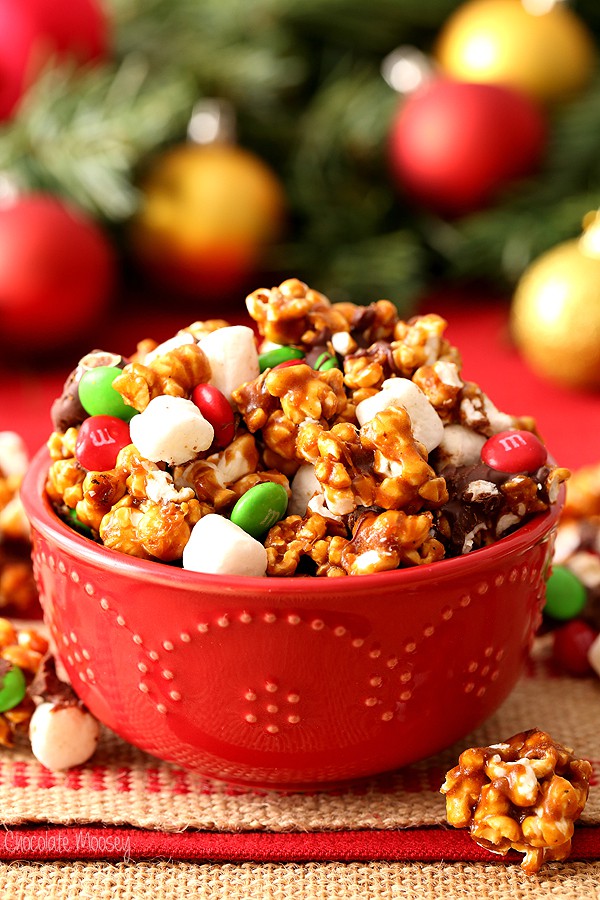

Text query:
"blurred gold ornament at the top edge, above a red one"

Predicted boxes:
[[435, 0, 596, 103]]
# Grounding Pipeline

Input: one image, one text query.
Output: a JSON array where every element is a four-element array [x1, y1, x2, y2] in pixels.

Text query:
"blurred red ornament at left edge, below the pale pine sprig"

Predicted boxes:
[[0, 194, 116, 352]]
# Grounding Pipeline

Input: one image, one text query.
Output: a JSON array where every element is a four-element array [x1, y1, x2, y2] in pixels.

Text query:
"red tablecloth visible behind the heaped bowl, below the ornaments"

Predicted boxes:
[[0, 297, 600, 469]]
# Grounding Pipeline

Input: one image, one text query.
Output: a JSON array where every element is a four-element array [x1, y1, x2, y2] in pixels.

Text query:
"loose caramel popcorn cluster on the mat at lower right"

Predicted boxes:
[[441, 728, 592, 875]]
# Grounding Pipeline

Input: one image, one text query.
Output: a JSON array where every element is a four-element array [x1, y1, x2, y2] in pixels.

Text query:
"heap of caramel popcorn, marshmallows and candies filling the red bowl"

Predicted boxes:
[[47, 279, 569, 576]]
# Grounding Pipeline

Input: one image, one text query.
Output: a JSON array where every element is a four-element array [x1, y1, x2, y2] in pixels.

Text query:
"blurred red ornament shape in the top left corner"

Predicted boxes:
[[0, 0, 108, 120]]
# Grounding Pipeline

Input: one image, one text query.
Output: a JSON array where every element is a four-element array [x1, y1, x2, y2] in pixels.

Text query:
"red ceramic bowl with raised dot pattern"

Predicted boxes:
[[22, 451, 559, 789]]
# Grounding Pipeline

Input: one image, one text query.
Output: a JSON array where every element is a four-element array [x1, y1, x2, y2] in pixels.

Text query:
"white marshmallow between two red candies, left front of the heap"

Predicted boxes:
[[129, 394, 215, 465]]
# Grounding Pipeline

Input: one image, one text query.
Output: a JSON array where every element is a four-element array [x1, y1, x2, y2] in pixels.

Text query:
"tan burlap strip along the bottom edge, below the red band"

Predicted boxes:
[[0, 862, 600, 900]]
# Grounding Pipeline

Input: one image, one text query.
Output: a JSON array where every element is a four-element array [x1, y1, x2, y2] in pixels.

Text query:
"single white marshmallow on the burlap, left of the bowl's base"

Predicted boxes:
[[29, 702, 100, 772]]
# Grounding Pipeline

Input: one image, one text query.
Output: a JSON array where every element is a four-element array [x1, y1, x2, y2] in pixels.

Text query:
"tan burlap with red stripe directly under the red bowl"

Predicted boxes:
[[0, 642, 600, 832]]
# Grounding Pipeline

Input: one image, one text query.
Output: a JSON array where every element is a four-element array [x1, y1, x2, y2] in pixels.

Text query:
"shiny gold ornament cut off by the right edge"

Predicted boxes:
[[511, 212, 600, 389]]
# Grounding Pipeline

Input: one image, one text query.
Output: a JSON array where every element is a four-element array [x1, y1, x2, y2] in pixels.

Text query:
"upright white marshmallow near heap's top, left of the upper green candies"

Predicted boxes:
[[199, 325, 260, 403]]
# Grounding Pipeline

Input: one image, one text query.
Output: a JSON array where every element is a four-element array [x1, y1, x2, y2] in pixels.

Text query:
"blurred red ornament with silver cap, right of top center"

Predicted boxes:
[[389, 79, 546, 216]]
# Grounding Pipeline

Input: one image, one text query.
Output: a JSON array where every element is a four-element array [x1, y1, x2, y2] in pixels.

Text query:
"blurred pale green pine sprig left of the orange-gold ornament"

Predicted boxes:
[[0, 54, 195, 221]]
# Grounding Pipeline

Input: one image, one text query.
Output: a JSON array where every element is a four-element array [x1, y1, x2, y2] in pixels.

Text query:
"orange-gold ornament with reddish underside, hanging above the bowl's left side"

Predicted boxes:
[[129, 140, 285, 298]]
